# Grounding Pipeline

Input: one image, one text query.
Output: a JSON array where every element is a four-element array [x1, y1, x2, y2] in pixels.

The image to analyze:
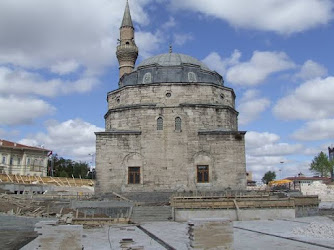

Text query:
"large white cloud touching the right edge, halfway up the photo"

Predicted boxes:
[[273, 77, 334, 120]]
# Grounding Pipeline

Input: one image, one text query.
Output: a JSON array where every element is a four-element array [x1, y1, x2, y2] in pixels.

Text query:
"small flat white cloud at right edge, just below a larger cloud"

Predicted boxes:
[[292, 119, 334, 141]]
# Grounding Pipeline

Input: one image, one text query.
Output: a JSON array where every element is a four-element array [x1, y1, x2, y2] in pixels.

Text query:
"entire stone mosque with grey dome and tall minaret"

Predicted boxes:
[[96, 0, 246, 194]]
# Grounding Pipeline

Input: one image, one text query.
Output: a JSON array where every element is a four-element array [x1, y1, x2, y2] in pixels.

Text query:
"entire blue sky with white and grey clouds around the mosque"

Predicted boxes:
[[0, 0, 334, 180]]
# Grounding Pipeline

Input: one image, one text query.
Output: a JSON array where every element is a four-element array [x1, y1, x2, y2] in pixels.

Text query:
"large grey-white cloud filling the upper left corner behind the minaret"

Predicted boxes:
[[0, 0, 152, 73]]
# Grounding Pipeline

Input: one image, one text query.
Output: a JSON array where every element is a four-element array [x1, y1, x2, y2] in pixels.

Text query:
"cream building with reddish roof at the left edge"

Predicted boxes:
[[0, 139, 49, 176]]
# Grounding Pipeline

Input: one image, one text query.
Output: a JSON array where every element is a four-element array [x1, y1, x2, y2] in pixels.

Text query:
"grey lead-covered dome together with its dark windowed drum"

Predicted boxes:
[[119, 53, 224, 87]]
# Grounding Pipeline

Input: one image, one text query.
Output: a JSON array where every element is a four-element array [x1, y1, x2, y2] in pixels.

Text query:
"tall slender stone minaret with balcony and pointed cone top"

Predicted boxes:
[[116, 1, 138, 78]]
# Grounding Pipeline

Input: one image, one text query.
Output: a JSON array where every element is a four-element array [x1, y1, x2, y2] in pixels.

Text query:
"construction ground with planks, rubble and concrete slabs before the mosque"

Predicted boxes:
[[0, 174, 334, 249]]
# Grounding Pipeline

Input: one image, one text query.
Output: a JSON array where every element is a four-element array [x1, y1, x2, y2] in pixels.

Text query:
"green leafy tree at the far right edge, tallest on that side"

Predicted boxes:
[[310, 151, 334, 177]]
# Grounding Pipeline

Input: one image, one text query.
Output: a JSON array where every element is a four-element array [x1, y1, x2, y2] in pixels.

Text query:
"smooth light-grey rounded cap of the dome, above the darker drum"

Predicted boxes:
[[137, 53, 210, 70]]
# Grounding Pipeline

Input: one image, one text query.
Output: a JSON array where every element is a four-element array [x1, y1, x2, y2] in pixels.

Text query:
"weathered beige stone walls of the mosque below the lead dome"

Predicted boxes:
[[96, 85, 246, 193]]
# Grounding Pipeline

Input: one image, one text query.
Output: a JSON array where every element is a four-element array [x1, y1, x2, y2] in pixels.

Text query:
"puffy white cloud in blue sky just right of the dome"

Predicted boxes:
[[226, 51, 295, 86]]
